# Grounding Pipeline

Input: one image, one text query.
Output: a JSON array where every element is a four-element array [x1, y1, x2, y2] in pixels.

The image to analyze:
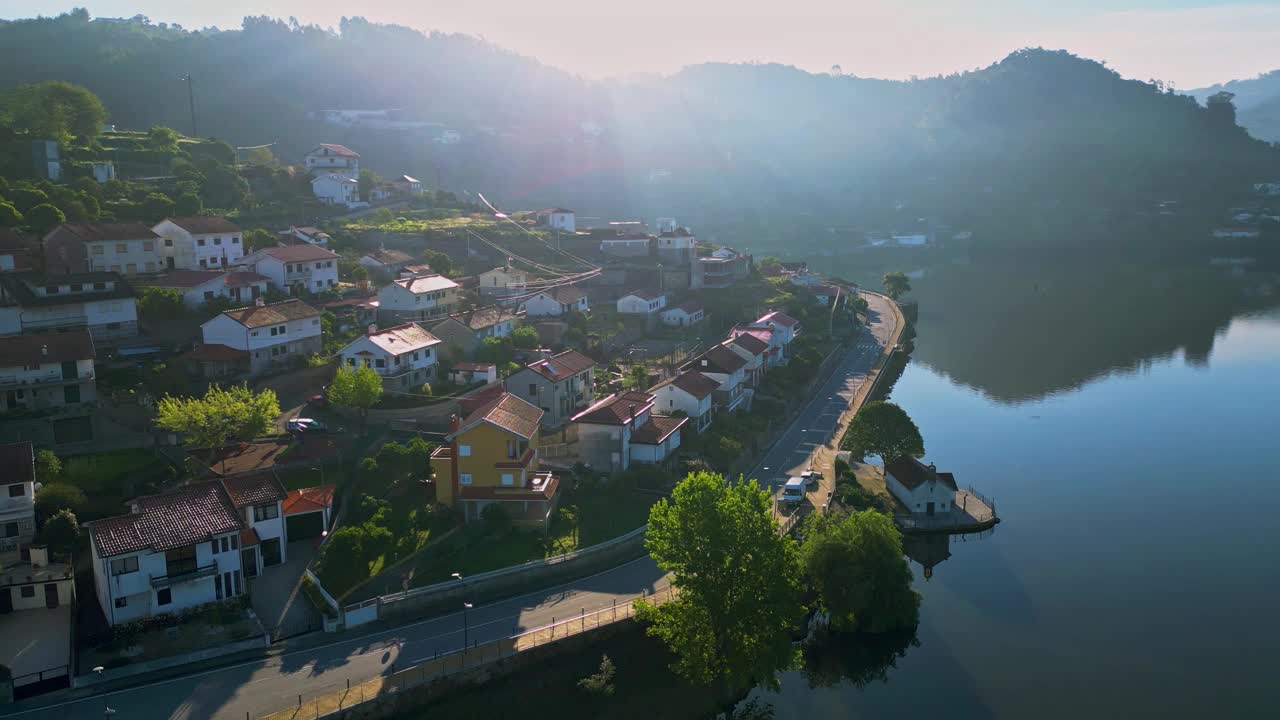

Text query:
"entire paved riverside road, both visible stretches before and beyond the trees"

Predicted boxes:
[[0, 296, 895, 720]]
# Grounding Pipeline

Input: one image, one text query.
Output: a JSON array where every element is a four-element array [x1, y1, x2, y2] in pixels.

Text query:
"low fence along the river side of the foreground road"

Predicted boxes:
[[261, 585, 678, 720]]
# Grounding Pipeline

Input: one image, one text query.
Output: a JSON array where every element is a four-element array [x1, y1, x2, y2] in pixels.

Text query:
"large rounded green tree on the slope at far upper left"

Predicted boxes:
[[4, 81, 106, 145]]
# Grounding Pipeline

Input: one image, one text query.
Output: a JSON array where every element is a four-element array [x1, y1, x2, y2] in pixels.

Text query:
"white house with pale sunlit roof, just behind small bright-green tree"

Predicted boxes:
[[338, 323, 440, 392]]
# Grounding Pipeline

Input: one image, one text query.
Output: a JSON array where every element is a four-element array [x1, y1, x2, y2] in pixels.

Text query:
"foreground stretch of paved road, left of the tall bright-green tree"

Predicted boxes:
[[0, 557, 667, 720]]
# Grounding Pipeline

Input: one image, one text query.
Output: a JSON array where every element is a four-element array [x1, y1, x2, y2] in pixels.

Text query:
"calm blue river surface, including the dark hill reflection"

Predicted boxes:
[[753, 260, 1280, 719]]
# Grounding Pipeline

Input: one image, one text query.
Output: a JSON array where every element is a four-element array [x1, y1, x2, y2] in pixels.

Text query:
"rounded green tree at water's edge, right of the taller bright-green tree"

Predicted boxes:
[[800, 510, 920, 633]]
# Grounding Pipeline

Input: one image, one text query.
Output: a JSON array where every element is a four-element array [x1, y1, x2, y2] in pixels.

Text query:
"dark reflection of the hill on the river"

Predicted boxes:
[[913, 264, 1280, 404]]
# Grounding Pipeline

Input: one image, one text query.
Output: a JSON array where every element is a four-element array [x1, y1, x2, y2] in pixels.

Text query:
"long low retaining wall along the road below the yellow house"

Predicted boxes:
[[378, 528, 644, 620]]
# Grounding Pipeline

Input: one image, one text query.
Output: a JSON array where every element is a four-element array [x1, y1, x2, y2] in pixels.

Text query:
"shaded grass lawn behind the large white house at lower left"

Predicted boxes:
[[59, 450, 177, 521]]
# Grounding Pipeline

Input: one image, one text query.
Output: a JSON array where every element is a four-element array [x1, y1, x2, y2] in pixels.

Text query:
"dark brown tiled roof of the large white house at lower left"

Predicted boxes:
[[88, 482, 244, 557]]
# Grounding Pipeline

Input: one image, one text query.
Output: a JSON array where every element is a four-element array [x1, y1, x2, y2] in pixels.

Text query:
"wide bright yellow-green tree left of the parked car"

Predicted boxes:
[[155, 386, 280, 468]]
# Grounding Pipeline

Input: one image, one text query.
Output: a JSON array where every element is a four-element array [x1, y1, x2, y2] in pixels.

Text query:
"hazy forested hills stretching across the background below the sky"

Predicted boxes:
[[0, 13, 1280, 250]]
